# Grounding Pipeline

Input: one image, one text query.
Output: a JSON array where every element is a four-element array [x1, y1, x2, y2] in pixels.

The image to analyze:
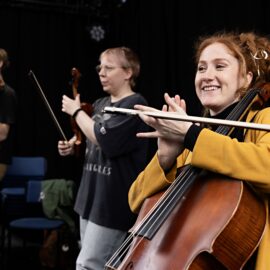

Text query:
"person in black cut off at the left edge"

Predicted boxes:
[[0, 48, 17, 181]]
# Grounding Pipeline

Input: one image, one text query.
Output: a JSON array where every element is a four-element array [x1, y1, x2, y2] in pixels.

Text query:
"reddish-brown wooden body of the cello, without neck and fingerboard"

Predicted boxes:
[[113, 174, 266, 270]]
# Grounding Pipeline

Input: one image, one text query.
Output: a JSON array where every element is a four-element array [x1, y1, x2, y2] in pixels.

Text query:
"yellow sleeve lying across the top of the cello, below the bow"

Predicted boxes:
[[191, 108, 270, 193]]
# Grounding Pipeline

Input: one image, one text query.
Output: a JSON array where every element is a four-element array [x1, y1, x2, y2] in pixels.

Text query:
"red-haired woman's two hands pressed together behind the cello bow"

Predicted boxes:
[[135, 93, 192, 170]]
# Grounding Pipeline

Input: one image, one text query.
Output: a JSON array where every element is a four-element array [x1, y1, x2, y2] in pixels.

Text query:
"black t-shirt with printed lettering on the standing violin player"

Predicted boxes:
[[75, 93, 148, 230]]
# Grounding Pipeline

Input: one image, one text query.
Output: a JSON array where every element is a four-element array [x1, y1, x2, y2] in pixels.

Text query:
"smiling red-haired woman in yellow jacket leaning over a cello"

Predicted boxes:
[[129, 32, 270, 270]]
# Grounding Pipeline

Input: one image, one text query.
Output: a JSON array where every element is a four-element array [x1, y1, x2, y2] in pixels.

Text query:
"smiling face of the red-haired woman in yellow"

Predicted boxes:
[[195, 43, 252, 115]]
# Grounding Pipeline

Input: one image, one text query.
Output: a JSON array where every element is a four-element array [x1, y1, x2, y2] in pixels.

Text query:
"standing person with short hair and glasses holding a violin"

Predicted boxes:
[[58, 47, 148, 270]]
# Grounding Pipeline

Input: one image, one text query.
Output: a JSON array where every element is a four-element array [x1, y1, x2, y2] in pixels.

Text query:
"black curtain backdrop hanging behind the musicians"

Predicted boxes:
[[0, 0, 270, 180]]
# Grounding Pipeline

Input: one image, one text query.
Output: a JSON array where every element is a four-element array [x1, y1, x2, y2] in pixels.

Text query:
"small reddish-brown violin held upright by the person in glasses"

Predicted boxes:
[[71, 67, 93, 157]]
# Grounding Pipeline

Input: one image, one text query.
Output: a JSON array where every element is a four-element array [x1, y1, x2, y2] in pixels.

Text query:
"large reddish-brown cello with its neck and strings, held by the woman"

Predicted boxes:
[[105, 84, 270, 270]]
